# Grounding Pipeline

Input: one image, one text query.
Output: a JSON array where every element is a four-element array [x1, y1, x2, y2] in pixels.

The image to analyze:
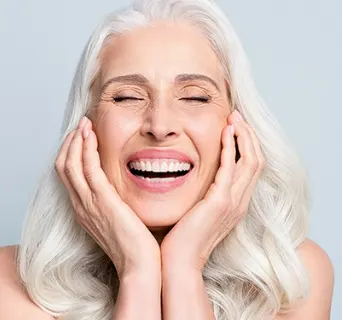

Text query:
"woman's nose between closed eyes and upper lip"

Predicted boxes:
[[141, 106, 181, 141]]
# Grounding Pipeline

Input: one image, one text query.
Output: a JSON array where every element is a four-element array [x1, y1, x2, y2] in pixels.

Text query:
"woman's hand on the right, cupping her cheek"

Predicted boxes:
[[161, 112, 265, 272]]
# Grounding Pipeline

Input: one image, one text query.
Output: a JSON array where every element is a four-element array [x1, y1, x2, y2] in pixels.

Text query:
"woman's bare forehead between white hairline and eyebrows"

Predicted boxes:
[[101, 22, 224, 85]]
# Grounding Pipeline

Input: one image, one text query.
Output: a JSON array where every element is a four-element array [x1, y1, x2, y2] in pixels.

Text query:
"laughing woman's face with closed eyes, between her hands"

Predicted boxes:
[[90, 22, 231, 231]]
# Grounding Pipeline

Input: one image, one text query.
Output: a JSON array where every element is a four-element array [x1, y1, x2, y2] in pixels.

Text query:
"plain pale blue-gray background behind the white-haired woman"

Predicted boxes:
[[0, 0, 342, 320]]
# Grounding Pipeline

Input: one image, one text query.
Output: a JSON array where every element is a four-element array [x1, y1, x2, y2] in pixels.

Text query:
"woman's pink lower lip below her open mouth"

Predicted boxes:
[[126, 166, 193, 193]]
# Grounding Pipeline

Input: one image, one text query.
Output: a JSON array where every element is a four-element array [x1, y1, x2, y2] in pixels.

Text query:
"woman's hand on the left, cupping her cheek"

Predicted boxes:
[[55, 118, 161, 279]]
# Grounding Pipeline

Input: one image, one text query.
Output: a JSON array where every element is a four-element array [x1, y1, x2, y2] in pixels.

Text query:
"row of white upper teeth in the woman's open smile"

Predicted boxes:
[[129, 159, 190, 172]]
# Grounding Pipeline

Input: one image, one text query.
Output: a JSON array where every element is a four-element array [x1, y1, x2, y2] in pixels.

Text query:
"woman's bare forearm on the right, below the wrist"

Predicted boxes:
[[162, 270, 215, 320]]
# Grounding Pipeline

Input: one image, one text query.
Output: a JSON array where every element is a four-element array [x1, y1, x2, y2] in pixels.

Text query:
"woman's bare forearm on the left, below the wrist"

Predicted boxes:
[[112, 275, 161, 320]]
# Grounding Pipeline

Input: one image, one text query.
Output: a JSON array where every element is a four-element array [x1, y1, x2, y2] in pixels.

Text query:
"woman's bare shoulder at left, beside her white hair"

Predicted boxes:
[[0, 245, 54, 320]]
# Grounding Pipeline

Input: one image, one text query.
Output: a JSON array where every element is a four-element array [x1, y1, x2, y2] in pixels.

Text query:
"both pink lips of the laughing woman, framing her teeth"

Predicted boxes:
[[126, 149, 193, 193]]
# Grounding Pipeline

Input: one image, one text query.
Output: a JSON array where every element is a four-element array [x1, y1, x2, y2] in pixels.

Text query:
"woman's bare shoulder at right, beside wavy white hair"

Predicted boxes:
[[276, 238, 334, 320]]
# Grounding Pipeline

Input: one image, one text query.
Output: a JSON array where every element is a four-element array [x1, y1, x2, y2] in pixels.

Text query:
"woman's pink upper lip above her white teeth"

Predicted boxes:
[[127, 149, 193, 164]]
